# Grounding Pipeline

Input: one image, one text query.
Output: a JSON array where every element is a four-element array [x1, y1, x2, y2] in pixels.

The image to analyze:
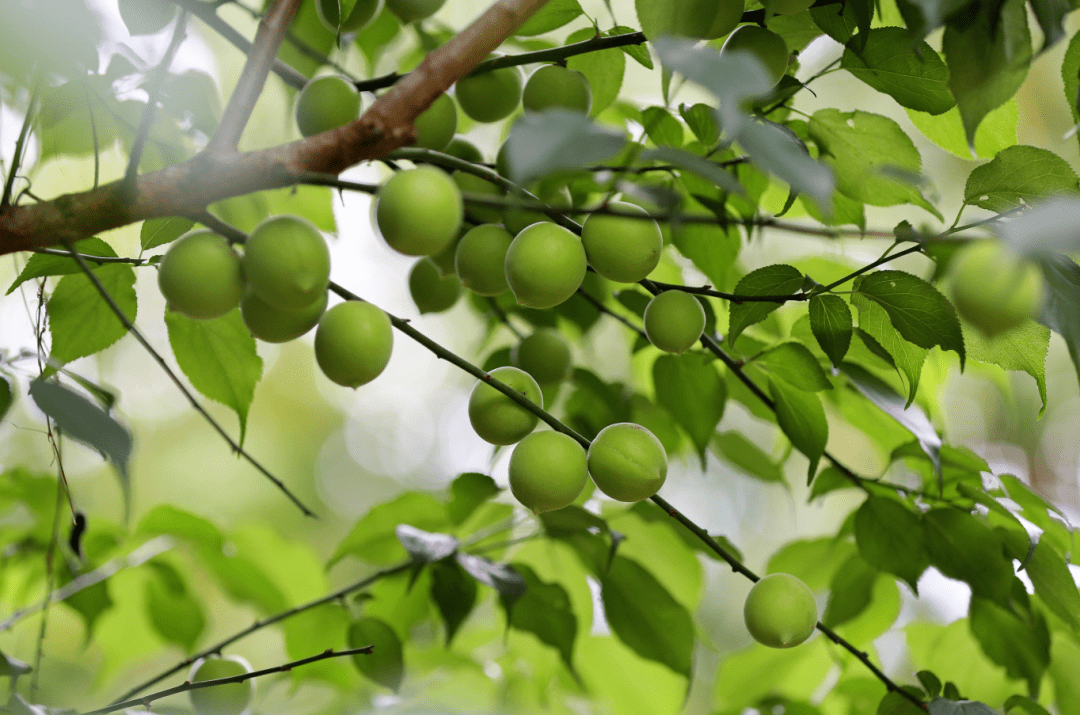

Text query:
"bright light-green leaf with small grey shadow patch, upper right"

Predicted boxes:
[[809, 109, 942, 220]]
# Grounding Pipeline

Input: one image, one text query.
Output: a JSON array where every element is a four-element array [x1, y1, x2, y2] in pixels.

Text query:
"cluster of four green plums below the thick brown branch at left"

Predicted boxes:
[[158, 216, 393, 388]]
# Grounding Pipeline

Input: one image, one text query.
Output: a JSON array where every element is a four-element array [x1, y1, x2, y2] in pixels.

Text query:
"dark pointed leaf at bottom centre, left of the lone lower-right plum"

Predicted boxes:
[[602, 555, 693, 678]]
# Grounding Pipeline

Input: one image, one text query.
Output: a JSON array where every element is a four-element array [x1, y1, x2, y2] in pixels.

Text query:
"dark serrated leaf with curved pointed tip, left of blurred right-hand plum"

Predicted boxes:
[[858, 271, 966, 369]]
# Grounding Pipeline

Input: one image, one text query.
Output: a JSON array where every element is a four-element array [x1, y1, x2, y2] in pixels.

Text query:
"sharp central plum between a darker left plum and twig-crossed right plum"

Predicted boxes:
[[504, 224, 588, 309]]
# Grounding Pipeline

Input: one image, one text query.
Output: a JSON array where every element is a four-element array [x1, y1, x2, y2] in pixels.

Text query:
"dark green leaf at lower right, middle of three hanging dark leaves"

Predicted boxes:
[[922, 509, 1014, 605]]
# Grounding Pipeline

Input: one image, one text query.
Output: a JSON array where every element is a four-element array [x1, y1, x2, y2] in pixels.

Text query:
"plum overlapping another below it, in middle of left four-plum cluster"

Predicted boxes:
[[244, 216, 330, 311]]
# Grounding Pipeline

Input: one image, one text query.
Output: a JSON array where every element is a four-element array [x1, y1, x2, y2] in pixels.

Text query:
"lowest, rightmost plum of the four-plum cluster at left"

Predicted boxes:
[[315, 300, 394, 388]]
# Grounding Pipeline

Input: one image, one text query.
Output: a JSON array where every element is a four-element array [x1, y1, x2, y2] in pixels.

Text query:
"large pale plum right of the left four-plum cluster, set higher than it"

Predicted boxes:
[[375, 166, 464, 256]]
